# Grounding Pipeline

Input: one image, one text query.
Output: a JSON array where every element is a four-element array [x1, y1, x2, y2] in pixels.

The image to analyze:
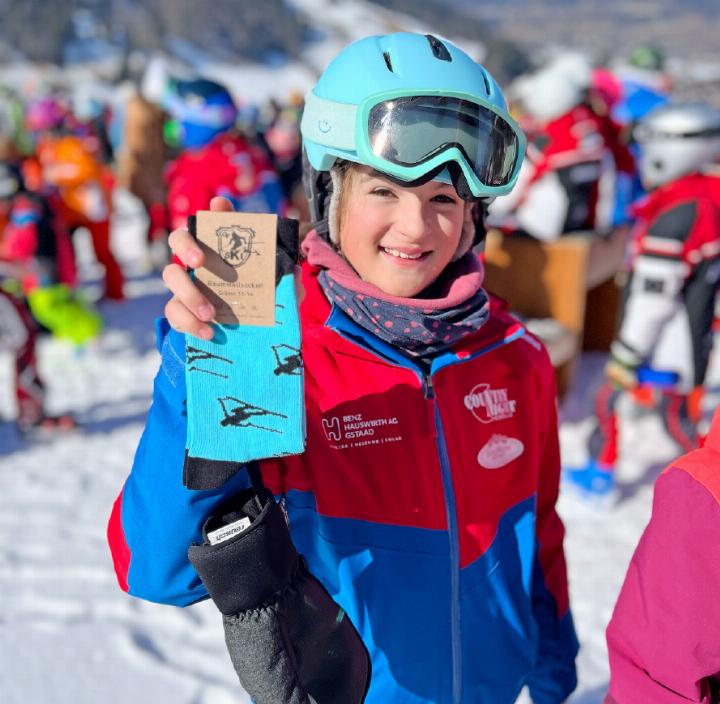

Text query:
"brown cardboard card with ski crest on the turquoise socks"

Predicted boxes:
[[195, 210, 278, 326]]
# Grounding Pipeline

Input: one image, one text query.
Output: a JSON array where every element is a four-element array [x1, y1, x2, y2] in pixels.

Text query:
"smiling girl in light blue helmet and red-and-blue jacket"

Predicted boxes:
[[109, 33, 578, 704]]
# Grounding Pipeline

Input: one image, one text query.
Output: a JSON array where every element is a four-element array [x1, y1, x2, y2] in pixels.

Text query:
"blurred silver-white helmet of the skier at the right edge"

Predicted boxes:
[[633, 102, 720, 189]]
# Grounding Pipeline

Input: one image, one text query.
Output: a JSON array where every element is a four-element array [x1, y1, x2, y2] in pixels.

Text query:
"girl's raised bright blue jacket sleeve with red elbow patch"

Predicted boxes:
[[108, 319, 248, 606]]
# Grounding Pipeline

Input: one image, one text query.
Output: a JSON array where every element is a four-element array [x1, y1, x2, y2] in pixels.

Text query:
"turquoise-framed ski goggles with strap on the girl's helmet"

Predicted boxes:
[[302, 92, 525, 198]]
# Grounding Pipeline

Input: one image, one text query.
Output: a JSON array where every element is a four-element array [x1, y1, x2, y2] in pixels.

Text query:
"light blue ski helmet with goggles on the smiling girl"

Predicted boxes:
[[301, 33, 525, 209]]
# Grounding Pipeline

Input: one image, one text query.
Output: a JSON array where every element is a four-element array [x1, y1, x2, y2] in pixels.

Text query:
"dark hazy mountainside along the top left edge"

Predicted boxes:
[[0, 0, 310, 63]]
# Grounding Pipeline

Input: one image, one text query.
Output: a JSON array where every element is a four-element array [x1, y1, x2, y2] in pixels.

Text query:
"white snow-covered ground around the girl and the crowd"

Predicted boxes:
[[0, 190, 716, 704]]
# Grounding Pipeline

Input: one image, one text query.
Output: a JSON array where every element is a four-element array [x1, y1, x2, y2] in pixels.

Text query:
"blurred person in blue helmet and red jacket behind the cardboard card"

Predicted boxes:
[[165, 78, 284, 234]]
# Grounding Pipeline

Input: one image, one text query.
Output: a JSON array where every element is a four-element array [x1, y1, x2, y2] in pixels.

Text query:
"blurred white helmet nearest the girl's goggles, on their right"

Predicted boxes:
[[511, 52, 592, 123]]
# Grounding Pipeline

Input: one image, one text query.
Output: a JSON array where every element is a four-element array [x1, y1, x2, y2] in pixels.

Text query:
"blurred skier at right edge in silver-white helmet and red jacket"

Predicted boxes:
[[566, 103, 720, 494]]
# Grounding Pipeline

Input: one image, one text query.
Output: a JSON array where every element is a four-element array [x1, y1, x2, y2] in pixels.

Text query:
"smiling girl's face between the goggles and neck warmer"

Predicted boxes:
[[339, 165, 470, 298]]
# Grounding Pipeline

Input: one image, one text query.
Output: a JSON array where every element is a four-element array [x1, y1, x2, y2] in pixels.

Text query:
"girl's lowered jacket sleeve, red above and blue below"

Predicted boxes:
[[527, 352, 579, 704]]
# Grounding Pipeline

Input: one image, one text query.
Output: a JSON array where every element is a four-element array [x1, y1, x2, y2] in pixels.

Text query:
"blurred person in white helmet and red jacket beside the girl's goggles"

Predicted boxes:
[[490, 54, 634, 242]]
